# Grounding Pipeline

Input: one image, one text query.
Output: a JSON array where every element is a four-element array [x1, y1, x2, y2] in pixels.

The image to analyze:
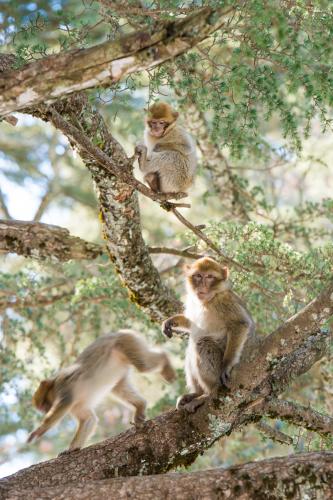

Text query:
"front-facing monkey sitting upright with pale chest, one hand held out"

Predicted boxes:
[[162, 257, 254, 412]]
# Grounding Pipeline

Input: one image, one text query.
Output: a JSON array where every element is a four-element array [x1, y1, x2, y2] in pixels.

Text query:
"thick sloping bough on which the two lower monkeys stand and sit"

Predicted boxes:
[[1, 287, 333, 489]]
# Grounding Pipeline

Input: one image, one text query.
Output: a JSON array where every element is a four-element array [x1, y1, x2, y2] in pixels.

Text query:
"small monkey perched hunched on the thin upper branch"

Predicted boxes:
[[135, 102, 197, 193]]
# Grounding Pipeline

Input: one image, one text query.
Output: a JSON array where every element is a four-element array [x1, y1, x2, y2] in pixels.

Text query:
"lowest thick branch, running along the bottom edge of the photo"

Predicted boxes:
[[0, 452, 333, 500]]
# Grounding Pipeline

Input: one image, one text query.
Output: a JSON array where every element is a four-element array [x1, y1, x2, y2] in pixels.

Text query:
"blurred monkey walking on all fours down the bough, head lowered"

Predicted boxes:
[[28, 330, 175, 451]]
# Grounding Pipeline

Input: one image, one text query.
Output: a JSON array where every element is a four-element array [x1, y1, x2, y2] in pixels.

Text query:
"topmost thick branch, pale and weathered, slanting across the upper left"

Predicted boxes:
[[0, 7, 236, 115]]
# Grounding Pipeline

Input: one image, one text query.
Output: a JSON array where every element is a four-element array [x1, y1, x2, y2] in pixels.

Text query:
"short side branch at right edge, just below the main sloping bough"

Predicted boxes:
[[265, 398, 333, 436]]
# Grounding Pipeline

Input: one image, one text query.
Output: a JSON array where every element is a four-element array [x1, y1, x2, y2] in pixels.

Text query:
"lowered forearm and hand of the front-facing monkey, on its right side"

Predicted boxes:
[[221, 318, 252, 387]]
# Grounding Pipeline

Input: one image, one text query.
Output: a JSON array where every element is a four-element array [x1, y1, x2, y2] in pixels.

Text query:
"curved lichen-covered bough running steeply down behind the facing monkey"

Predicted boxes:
[[32, 94, 182, 321]]
